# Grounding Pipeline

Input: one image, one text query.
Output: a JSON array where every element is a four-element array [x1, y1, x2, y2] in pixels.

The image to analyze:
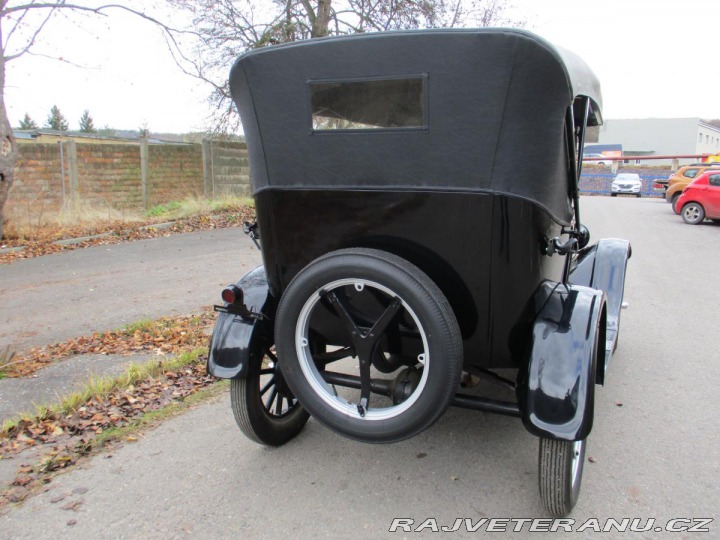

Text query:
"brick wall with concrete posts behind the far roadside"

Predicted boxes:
[[5, 141, 250, 218]]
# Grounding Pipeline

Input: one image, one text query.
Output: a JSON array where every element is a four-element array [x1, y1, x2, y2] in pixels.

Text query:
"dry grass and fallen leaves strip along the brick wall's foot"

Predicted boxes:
[[0, 197, 255, 264]]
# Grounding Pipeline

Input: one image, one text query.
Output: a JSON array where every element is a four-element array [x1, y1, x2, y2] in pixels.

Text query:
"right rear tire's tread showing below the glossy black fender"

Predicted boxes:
[[538, 437, 586, 517]]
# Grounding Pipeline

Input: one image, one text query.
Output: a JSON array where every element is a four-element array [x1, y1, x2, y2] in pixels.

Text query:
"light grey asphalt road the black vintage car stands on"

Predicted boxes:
[[0, 197, 720, 539]]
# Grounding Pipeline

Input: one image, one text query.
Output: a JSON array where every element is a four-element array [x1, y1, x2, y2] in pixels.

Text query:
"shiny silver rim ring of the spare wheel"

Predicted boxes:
[[295, 279, 431, 422]]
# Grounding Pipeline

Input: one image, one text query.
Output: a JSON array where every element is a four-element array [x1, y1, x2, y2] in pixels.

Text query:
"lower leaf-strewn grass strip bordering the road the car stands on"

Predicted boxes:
[[0, 347, 227, 508]]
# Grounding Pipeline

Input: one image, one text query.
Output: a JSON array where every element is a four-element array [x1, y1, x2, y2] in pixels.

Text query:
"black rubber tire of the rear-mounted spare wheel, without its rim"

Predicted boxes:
[[275, 248, 463, 443]]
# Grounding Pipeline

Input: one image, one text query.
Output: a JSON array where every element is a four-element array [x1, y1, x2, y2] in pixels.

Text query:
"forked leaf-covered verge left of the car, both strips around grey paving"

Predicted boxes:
[[0, 310, 226, 507]]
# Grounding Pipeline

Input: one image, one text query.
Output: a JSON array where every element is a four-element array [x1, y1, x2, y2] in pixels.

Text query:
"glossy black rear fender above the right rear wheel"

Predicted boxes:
[[518, 282, 605, 441]]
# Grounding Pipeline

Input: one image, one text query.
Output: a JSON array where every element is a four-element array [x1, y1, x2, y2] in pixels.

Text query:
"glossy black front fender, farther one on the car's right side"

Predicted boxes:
[[569, 238, 632, 384]]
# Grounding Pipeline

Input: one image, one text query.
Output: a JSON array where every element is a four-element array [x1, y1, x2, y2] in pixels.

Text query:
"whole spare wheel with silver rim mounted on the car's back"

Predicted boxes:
[[275, 248, 463, 443]]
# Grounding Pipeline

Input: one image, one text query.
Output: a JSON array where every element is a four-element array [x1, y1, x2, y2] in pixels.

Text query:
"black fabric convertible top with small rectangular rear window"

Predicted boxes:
[[230, 29, 602, 224]]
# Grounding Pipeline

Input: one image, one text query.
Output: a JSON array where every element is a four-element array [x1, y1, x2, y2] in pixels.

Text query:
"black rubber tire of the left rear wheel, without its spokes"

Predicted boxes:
[[230, 346, 310, 446]]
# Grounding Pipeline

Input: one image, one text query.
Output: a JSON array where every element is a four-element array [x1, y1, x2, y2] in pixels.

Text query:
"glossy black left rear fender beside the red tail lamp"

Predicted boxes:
[[207, 266, 274, 379]]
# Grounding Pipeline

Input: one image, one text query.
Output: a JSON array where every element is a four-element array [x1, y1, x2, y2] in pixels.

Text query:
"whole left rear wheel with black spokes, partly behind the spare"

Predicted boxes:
[[230, 343, 309, 446]]
